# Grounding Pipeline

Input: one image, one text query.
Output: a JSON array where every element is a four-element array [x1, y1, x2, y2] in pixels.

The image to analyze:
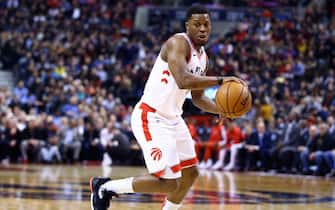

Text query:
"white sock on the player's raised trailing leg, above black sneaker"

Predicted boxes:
[[99, 177, 134, 197]]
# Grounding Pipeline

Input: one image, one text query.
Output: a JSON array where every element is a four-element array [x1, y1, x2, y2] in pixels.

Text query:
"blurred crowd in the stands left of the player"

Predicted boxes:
[[0, 0, 159, 164]]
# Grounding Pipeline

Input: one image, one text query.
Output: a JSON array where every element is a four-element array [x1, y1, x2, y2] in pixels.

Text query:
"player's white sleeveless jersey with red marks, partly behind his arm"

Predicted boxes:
[[141, 33, 207, 118]]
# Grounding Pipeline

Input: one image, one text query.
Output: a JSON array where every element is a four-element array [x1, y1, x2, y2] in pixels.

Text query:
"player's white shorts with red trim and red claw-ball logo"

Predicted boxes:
[[131, 102, 198, 179]]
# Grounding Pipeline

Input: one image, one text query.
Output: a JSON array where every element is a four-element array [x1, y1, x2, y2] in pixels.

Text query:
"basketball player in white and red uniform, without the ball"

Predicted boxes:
[[90, 6, 243, 210]]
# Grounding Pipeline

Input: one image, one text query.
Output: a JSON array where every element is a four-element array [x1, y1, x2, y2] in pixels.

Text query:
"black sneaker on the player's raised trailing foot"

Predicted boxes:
[[90, 177, 118, 210]]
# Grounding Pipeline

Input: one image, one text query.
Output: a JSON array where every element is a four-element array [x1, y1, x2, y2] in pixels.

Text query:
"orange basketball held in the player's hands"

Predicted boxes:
[[215, 81, 252, 119]]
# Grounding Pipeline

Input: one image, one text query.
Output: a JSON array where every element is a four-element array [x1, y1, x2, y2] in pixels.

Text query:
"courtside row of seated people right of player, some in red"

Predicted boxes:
[[192, 114, 335, 177]]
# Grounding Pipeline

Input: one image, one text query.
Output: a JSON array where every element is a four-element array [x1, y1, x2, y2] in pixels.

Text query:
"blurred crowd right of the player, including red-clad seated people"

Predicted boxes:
[[194, 0, 335, 176]]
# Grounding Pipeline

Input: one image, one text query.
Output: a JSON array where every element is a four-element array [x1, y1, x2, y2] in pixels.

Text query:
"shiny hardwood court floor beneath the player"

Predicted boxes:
[[0, 165, 335, 210]]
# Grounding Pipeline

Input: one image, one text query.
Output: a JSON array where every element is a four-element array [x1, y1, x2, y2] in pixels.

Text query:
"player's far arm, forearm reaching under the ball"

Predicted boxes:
[[191, 55, 219, 114]]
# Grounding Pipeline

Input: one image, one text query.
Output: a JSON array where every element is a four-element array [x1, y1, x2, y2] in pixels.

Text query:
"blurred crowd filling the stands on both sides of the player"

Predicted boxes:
[[0, 0, 335, 175]]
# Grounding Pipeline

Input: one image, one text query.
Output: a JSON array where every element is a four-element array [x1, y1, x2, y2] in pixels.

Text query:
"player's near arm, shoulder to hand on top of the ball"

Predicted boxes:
[[161, 36, 241, 90]]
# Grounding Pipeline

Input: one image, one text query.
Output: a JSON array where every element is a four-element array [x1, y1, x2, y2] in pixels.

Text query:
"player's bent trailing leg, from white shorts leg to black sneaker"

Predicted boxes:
[[91, 104, 181, 210]]
